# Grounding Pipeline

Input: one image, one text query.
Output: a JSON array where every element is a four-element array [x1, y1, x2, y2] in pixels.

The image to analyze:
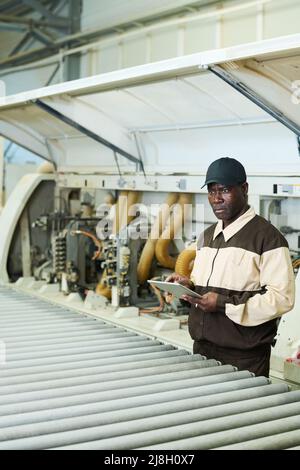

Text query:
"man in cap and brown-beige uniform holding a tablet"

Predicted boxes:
[[167, 158, 295, 377]]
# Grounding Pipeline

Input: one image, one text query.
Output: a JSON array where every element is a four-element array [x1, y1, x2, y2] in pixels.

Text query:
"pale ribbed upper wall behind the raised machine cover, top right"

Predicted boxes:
[[82, 0, 300, 76]]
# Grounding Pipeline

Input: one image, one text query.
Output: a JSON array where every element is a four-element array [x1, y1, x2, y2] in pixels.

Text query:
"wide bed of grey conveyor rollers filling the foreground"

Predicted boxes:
[[0, 288, 300, 450]]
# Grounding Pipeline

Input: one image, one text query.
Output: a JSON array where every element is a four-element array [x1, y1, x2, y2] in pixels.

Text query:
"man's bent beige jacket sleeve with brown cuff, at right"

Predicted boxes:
[[217, 247, 295, 326]]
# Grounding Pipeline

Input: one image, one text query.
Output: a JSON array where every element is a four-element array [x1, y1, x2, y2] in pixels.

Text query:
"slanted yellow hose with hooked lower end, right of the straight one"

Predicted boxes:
[[155, 193, 193, 269]]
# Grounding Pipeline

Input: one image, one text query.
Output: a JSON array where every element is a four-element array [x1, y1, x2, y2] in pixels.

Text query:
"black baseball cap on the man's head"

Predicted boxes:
[[201, 157, 247, 188]]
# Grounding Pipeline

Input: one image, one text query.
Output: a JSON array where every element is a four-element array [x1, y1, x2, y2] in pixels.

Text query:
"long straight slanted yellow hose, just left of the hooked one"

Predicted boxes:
[[137, 193, 179, 284]]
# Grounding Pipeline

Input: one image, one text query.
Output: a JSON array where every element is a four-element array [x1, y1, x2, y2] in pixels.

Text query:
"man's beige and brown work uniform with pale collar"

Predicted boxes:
[[189, 208, 295, 375]]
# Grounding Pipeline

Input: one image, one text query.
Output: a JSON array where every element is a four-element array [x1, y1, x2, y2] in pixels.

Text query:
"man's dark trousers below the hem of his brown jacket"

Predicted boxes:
[[193, 341, 271, 377]]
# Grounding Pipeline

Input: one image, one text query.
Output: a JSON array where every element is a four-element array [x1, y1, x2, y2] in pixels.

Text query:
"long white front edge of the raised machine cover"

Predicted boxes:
[[0, 33, 300, 110]]
